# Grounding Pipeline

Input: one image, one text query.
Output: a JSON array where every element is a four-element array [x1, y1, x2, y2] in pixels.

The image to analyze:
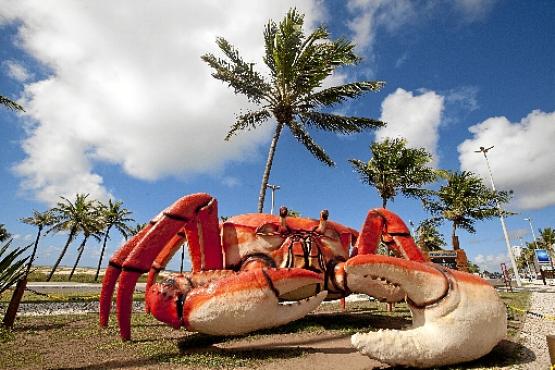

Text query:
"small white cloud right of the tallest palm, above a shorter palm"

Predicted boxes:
[[376, 88, 444, 166]]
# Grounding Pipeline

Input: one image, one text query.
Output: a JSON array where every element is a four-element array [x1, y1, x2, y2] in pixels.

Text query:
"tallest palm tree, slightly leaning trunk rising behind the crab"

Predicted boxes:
[[202, 9, 384, 212]]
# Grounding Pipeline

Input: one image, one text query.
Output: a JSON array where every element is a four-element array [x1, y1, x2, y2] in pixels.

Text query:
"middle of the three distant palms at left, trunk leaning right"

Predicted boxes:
[[46, 194, 96, 281]]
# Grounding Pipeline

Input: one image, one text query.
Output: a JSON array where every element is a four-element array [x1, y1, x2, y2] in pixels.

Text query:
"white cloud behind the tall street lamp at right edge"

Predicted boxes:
[[458, 110, 555, 209]]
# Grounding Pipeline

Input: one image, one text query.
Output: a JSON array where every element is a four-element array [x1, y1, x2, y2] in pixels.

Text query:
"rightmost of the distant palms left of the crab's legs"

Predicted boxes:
[[94, 199, 135, 281]]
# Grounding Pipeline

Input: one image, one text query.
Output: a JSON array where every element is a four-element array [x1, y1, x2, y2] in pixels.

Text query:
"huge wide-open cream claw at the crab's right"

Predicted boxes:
[[345, 255, 507, 367]]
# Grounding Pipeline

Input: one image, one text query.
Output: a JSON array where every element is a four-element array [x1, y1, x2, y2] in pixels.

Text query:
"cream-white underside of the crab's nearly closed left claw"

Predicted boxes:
[[187, 289, 327, 335]]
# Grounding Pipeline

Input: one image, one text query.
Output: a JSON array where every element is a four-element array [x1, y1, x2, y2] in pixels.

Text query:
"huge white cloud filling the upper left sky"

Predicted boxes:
[[0, 0, 323, 203]]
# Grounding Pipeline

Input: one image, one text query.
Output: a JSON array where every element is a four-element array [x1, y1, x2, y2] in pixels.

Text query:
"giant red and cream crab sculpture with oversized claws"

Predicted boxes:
[[100, 193, 507, 367]]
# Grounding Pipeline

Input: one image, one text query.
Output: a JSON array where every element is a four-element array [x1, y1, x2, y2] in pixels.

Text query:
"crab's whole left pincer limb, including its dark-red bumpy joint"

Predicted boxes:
[[146, 269, 327, 335]]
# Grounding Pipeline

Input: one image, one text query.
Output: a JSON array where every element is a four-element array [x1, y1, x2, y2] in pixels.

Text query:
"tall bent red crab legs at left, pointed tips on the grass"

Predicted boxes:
[[100, 193, 223, 339]]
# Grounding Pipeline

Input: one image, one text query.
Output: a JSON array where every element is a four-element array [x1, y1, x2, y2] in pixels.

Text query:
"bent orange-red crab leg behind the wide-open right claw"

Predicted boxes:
[[355, 208, 424, 261]]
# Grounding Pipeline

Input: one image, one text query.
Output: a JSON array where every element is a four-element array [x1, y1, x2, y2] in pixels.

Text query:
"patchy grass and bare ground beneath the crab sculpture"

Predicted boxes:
[[0, 292, 529, 369]]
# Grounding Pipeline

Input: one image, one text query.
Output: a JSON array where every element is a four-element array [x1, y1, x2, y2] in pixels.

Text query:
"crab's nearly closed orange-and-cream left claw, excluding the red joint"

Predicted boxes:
[[183, 269, 327, 335]]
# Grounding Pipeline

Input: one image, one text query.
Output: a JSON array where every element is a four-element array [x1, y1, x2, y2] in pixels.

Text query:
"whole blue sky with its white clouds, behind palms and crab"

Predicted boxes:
[[0, 0, 555, 270]]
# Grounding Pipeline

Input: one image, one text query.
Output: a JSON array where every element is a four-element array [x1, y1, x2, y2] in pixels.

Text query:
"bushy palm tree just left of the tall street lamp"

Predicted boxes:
[[423, 171, 511, 250]]
